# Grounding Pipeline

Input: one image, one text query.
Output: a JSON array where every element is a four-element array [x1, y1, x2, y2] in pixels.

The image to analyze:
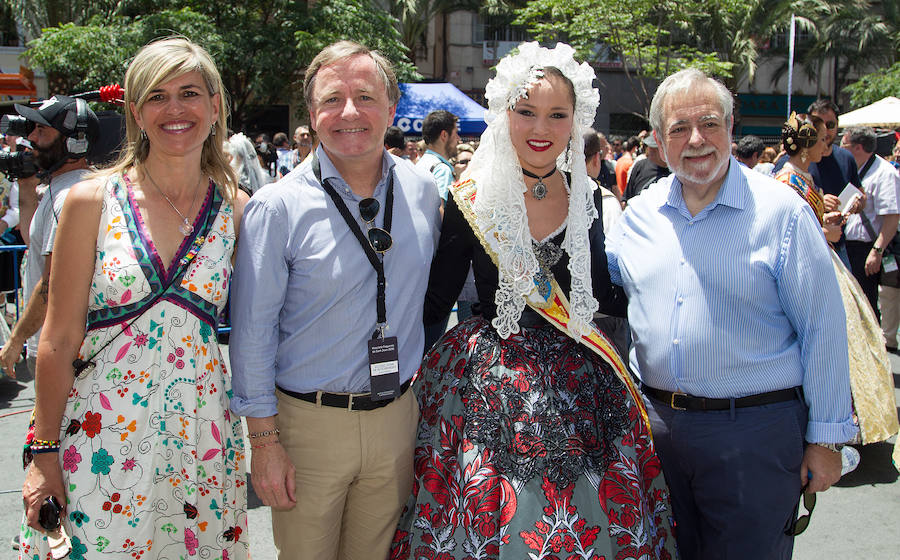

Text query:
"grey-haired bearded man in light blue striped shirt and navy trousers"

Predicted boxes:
[[607, 70, 856, 560]]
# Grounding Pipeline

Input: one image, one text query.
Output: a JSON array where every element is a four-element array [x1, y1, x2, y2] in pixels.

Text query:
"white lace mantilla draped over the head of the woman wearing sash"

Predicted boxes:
[[469, 43, 600, 338]]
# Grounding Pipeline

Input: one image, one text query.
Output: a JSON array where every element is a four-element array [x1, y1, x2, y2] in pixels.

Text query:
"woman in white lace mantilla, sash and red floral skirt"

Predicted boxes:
[[392, 43, 675, 560]]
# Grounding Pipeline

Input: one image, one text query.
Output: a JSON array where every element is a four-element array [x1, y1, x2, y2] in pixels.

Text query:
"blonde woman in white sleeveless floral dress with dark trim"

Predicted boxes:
[[20, 39, 247, 560]]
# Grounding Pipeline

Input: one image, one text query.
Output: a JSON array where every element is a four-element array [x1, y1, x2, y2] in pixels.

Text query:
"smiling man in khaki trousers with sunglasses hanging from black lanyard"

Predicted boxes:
[[231, 41, 440, 559]]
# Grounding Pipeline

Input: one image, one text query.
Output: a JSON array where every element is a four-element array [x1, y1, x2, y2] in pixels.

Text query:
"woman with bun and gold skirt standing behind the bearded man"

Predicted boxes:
[[775, 114, 900, 472]]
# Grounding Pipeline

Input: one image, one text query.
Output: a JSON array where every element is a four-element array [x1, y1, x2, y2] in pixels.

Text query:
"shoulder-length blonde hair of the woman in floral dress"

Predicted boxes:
[[105, 37, 238, 201]]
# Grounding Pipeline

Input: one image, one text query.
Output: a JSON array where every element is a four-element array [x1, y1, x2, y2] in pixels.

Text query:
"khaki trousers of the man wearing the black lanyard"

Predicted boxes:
[[272, 389, 419, 560]]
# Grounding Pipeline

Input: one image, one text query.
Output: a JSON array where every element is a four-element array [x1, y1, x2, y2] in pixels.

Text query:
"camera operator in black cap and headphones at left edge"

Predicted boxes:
[[0, 95, 100, 378]]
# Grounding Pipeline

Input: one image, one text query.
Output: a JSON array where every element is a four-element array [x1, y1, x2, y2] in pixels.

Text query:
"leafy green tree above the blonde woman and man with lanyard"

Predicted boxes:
[[19, 0, 420, 129]]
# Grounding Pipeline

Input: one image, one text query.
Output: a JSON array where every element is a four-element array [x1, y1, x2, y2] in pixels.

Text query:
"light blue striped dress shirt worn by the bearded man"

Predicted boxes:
[[606, 158, 856, 443]]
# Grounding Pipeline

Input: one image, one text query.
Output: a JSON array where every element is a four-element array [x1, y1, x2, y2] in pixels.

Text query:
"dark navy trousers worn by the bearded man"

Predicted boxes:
[[644, 397, 807, 560]]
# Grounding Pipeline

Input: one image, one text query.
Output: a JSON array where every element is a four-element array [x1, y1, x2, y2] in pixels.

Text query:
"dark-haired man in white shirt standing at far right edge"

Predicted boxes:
[[841, 126, 900, 316]]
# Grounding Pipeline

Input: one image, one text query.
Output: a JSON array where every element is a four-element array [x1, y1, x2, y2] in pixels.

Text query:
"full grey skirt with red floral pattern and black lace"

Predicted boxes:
[[391, 317, 676, 560]]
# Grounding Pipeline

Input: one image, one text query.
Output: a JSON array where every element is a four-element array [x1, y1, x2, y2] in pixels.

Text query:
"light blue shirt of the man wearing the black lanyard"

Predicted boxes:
[[230, 147, 440, 417]]
